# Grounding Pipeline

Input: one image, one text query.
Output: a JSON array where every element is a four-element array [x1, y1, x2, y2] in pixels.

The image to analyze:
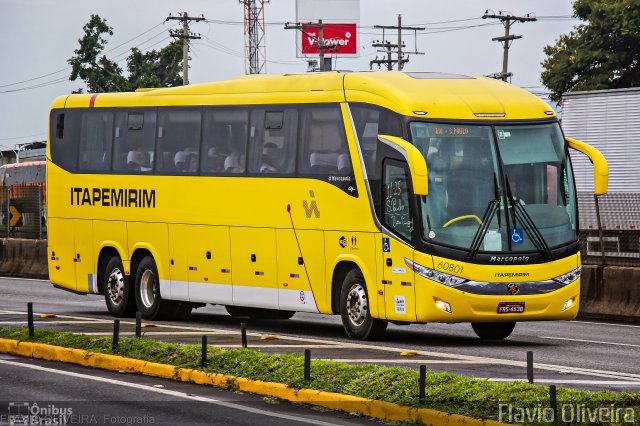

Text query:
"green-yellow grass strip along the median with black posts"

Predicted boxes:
[[0, 327, 640, 424]]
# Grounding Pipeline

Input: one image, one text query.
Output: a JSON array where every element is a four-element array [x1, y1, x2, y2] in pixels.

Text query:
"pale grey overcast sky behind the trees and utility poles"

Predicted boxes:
[[0, 0, 580, 150]]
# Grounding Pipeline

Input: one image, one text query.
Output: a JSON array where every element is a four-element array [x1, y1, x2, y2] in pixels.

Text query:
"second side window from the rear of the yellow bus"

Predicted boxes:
[[78, 110, 113, 172]]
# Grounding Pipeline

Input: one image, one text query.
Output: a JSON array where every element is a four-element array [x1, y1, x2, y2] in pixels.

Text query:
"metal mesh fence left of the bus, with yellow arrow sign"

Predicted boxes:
[[0, 185, 47, 239]]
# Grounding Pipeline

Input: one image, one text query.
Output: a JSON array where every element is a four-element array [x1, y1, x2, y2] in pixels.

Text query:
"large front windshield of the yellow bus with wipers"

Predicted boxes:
[[410, 121, 577, 253]]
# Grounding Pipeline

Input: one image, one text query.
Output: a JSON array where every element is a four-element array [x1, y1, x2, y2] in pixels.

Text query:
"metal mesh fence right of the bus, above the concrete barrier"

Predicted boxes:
[[578, 193, 640, 266]]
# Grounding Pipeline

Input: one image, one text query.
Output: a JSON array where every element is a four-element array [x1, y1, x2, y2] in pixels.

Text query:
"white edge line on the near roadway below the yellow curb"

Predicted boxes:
[[0, 359, 335, 426]]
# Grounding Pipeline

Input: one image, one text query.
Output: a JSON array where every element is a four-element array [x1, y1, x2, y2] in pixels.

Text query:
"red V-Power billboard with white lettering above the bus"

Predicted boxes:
[[301, 23, 358, 56]]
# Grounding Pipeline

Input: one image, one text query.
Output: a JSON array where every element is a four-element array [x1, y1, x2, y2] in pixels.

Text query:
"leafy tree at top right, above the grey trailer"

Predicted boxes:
[[541, 0, 640, 102]]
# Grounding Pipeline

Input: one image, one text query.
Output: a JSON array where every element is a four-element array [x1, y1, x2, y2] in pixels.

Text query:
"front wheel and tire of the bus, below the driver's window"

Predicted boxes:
[[340, 269, 387, 340]]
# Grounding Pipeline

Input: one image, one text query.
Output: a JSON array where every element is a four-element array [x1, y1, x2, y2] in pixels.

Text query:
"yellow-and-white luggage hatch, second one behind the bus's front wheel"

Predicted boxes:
[[230, 227, 278, 309]]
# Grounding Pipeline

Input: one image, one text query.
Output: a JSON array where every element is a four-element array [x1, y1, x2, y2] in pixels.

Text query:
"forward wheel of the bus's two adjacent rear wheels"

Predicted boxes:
[[135, 256, 192, 320]]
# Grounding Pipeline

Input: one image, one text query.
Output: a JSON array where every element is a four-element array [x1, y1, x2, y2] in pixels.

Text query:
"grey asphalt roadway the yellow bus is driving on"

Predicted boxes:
[[0, 278, 640, 391]]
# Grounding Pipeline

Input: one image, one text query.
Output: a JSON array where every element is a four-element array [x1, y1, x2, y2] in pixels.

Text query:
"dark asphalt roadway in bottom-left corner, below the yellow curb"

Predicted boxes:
[[0, 354, 379, 426]]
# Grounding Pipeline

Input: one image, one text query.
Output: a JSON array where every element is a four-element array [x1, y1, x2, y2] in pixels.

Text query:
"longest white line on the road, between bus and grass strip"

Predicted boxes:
[[5, 311, 640, 380]]
